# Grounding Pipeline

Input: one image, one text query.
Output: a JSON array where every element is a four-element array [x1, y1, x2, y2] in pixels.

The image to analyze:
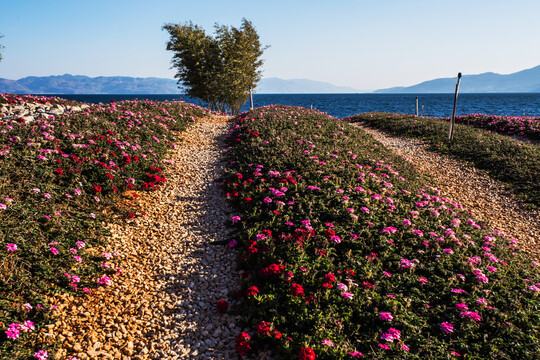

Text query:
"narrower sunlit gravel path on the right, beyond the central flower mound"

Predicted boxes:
[[354, 123, 540, 261]]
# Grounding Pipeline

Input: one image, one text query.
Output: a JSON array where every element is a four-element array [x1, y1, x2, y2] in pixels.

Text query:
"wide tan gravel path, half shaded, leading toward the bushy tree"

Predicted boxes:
[[47, 117, 245, 360]]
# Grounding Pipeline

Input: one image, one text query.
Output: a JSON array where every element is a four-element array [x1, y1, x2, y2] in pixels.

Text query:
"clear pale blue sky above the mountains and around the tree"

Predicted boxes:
[[0, 0, 540, 90]]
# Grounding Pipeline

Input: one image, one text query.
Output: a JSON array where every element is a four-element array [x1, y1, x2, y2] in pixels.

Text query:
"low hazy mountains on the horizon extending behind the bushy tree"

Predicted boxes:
[[0, 74, 359, 94]]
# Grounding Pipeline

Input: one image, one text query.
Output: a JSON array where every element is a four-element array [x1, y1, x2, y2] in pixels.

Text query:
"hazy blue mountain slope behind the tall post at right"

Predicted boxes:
[[375, 66, 540, 94]]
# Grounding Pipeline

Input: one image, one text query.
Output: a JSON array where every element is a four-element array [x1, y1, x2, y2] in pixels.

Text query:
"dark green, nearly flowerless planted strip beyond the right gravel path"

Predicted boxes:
[[344, 113, 540, 208]]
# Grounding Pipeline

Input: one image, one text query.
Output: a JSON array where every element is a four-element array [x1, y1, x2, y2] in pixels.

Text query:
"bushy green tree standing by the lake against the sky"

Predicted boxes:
[[163, 19, 264, 115]]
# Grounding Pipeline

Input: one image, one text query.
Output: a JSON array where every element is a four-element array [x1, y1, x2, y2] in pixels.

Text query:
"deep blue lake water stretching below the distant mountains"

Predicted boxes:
[[45, 93, 540, 118]]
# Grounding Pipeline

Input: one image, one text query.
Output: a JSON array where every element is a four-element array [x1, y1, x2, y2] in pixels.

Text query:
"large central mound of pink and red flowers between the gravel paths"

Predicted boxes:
[[223, 106, 540, 360]]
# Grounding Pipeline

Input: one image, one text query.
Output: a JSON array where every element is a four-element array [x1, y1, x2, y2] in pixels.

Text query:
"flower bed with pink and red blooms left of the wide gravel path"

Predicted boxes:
[[0, 94, 208, 359]]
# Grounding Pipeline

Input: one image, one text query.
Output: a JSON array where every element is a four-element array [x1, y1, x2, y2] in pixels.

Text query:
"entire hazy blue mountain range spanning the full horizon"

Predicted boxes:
[[4, 66, 540, 94]]
